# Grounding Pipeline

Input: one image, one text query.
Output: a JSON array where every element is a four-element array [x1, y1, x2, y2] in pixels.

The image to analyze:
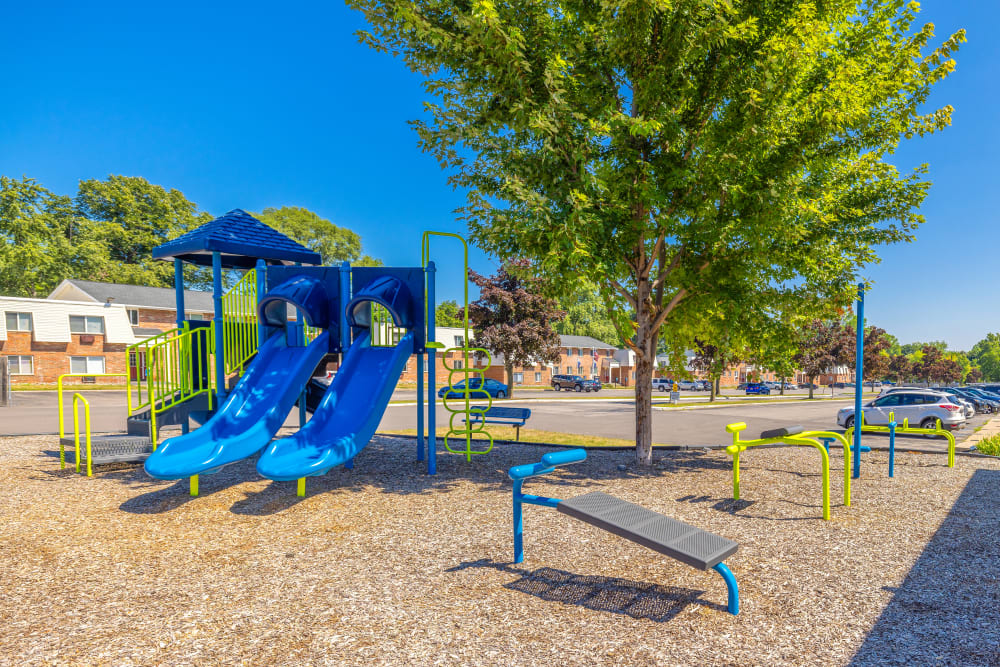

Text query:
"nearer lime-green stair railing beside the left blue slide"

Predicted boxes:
[[146, 327, 213, 449]]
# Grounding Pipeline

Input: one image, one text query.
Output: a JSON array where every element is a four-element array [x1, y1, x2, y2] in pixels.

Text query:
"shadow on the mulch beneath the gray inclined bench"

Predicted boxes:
[[447, 558, 726, 623]]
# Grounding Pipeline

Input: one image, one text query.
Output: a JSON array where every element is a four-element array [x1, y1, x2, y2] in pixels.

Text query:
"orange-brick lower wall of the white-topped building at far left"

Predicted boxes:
[[0, 331, 128, 386]]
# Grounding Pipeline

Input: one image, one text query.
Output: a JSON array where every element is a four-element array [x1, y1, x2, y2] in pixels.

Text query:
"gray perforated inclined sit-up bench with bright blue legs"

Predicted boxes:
[[507, 449, 740, 614]]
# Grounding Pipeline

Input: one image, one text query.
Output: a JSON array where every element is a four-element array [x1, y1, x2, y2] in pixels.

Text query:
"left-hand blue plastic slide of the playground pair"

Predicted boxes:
[[145, 331, 330, 479]]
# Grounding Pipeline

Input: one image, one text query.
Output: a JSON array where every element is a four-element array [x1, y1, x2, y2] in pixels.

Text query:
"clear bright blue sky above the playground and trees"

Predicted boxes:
[[0, 0, 1000, 349]]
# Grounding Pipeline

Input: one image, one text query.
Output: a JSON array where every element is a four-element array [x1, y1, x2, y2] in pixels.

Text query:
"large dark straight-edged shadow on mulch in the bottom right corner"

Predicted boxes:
[[850, 470, 1000, 666]]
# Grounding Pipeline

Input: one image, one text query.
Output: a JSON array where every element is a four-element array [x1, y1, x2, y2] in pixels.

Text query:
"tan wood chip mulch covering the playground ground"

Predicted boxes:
[[0, 436, 1000, 667]]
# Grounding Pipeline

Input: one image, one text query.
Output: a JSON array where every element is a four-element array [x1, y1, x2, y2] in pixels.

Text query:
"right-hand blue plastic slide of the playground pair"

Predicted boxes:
[[257, 332, 413, 481]]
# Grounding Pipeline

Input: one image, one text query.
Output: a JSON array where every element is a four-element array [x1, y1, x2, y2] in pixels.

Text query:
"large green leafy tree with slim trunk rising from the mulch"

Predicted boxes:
[[348, 0, 964, 464]]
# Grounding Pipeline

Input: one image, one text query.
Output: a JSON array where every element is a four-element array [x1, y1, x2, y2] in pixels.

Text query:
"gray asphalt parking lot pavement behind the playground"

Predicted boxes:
[[0, 391, 968, 454]]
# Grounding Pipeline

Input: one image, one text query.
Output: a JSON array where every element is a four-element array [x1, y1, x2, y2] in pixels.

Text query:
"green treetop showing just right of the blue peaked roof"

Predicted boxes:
[[251, 206, 382, 266]]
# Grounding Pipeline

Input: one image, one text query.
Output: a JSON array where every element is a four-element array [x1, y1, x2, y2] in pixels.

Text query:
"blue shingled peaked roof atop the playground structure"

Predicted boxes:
[[153, 208, 322, 269]]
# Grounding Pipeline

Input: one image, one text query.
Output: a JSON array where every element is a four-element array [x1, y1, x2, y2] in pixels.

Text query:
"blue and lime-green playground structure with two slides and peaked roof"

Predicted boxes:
[[52, 210, 500, 495]]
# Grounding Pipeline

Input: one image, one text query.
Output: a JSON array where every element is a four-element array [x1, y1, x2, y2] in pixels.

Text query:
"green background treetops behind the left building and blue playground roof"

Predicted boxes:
[[0, 175, 381, 297]]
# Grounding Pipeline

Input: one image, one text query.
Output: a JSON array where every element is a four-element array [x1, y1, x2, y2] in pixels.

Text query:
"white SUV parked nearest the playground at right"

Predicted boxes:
[[837, 389, 966, 431]]
